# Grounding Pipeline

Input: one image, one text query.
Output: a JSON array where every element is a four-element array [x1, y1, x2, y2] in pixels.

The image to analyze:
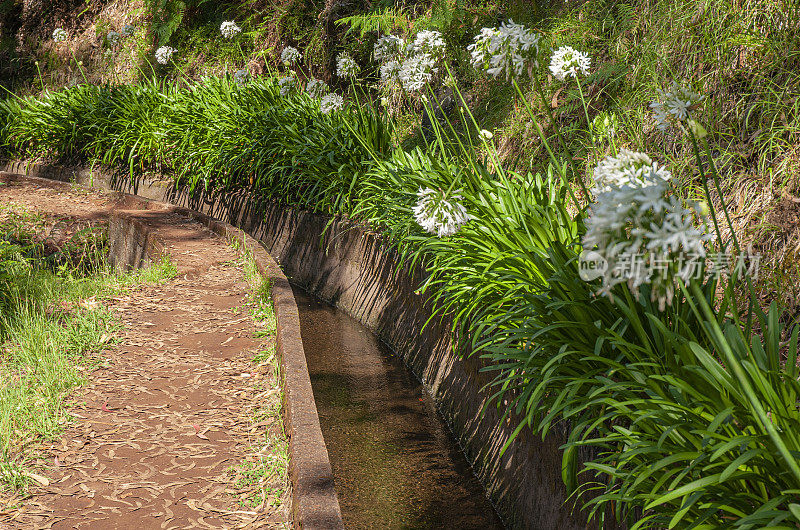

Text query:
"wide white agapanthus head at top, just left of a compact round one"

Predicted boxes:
[[467, 20, 540, 79]]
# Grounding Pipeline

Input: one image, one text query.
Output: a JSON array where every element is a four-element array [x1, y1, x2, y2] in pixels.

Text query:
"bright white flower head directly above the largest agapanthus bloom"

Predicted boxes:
[[593, 148, 672, 195]]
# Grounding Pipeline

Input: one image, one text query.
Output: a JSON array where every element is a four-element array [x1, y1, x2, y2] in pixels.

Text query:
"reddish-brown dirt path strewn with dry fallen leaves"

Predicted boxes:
[[0, 178, 288, 529]]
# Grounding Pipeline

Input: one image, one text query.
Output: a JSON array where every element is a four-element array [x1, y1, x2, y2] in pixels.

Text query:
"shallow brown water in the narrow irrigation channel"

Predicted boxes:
[[294, 287, 503, 529]]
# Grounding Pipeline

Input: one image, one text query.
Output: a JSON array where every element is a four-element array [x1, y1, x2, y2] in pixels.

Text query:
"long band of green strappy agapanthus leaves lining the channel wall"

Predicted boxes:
[[8, 69, 800, 526]]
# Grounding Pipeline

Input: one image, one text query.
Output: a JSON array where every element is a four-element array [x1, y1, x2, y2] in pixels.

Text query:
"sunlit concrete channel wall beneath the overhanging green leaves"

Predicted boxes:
[[0, 159, 589, 530]]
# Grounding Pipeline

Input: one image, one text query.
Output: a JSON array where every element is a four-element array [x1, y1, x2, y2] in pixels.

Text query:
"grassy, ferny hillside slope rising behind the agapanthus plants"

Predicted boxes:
[[0, 0, 800, 296]]
